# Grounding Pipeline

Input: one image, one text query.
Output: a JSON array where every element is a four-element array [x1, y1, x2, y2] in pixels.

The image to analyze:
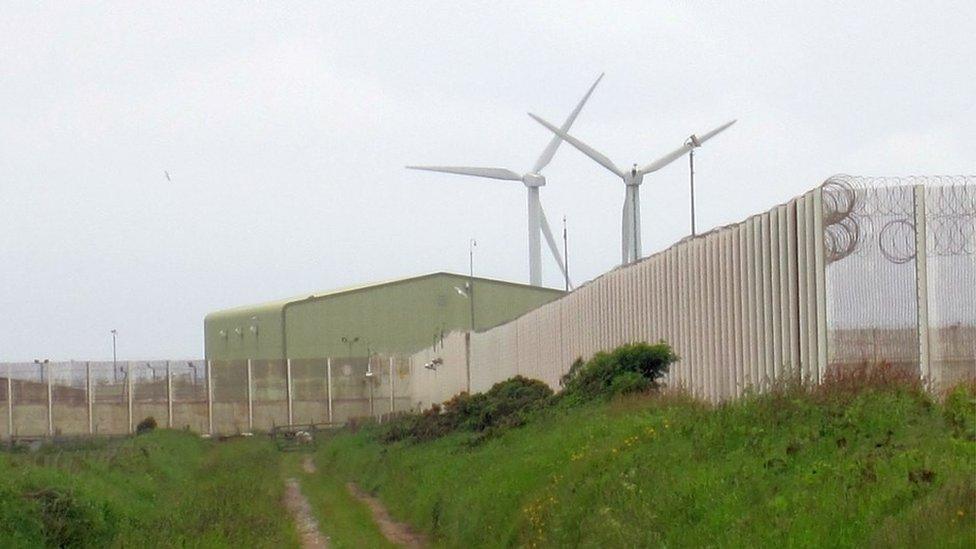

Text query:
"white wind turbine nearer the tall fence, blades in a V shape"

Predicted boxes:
[[529, 113, 736, 265]]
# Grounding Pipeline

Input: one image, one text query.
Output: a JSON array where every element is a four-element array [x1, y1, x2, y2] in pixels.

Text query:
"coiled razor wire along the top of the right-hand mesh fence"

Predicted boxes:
[[821, 174, 976, 264]]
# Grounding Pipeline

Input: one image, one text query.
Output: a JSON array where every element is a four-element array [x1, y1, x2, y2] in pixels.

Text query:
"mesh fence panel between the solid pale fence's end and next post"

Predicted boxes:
[[822, 176, 919, 368]]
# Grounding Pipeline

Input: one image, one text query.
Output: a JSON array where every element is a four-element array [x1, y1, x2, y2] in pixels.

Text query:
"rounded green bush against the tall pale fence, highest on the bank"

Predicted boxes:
[[561, 341, 678, 401]]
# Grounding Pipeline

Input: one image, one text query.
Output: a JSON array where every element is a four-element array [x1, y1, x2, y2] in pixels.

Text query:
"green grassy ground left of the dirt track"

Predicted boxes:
[[0, 431, 297, 547]]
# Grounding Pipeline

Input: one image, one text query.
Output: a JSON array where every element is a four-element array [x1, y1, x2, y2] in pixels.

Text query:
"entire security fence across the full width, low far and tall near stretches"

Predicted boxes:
[[0, 176, 976, 437]]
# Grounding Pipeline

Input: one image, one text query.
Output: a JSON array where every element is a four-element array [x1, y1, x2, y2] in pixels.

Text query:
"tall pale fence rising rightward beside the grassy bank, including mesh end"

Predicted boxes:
[[411, 176, 976, 407]]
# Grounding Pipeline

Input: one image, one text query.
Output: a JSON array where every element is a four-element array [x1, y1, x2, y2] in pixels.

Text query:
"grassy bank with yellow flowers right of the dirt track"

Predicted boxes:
[[317, 379, 976, 547]]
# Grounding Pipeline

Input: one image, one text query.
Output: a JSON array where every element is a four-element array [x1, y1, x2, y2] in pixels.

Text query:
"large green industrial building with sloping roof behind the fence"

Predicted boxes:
[[204, 272, 564, 360]]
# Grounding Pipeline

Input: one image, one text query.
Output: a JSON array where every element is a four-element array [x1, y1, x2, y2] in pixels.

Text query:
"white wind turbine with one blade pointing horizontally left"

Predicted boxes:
[[407, 73, 603, 286]]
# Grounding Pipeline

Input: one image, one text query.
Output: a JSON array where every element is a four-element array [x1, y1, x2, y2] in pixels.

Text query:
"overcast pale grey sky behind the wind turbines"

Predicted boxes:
[[0, 1, 976, 361]]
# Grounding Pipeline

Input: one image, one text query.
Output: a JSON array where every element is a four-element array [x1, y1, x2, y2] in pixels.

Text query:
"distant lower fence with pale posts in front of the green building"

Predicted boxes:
[[0, 356, 412, 439]]
